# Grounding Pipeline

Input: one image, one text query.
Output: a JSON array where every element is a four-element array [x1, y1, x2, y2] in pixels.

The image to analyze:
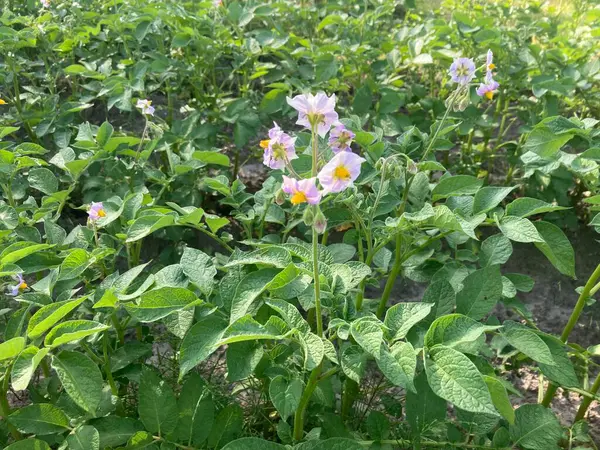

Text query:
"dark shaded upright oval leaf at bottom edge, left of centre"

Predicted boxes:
[[175, 373, 215, 447]]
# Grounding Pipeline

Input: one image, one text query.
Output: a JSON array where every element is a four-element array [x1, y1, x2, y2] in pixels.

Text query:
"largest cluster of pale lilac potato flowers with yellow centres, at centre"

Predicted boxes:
[[260, 92, 365, 232]]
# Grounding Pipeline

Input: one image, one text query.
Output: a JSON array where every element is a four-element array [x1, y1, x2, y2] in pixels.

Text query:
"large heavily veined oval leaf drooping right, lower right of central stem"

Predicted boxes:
[[425, 345, 498, 416]]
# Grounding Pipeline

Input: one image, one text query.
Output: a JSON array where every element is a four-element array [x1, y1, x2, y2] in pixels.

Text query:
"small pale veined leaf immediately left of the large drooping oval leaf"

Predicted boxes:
[[376, 342, 417, 392]]
